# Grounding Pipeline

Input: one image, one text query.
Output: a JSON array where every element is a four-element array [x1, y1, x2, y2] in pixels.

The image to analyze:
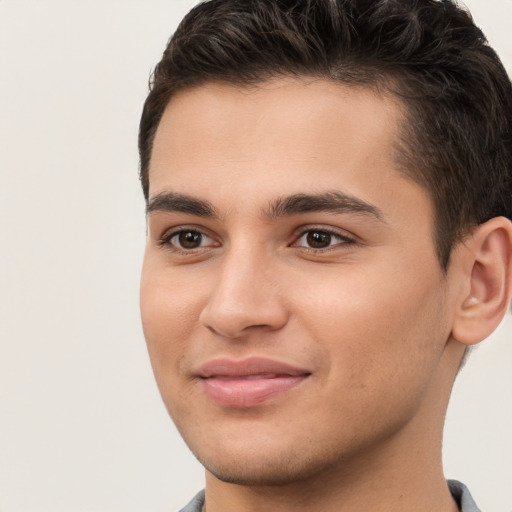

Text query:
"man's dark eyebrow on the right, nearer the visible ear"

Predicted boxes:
[[264, 191, 384, 222]]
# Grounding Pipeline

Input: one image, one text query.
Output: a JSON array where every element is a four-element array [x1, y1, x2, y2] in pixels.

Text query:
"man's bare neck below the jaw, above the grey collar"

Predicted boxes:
[[206, 434, 458, 512]]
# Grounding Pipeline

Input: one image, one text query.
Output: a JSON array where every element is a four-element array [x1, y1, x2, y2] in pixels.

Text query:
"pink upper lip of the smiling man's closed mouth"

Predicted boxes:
[[197, 357, 311, 379]]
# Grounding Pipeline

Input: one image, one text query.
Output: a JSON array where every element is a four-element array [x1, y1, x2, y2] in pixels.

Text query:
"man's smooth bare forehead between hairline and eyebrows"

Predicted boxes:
[[149, 79, 420, 216]]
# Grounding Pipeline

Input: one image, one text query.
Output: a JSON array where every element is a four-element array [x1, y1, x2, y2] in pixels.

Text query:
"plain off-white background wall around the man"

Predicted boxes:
[[0, 0, 512, 512]]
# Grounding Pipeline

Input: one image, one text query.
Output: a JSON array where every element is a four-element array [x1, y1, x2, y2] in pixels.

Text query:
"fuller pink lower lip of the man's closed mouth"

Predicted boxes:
[[202, 375, 308, 407]]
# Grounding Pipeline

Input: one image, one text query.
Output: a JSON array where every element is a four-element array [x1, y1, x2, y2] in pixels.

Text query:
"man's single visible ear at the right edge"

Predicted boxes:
[[452, 217, 512, 345]]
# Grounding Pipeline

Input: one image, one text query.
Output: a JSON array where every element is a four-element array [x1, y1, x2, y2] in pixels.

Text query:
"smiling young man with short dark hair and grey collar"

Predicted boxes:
[[139, 0, 512, 512]]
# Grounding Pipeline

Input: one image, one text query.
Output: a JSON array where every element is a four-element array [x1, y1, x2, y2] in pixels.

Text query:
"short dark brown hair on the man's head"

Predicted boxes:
[[139, 0, 512, 269]]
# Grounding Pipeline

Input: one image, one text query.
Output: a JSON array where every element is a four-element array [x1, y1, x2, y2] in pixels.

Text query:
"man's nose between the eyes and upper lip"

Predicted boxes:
[[199, 246, 288, 339]]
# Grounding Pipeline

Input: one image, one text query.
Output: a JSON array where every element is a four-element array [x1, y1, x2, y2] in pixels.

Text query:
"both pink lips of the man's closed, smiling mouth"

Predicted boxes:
[[198, 357, 311, 408]]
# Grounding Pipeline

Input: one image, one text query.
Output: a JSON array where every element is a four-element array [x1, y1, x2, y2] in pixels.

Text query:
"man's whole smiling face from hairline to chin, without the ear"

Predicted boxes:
[[141, 79, 456, 484]]
